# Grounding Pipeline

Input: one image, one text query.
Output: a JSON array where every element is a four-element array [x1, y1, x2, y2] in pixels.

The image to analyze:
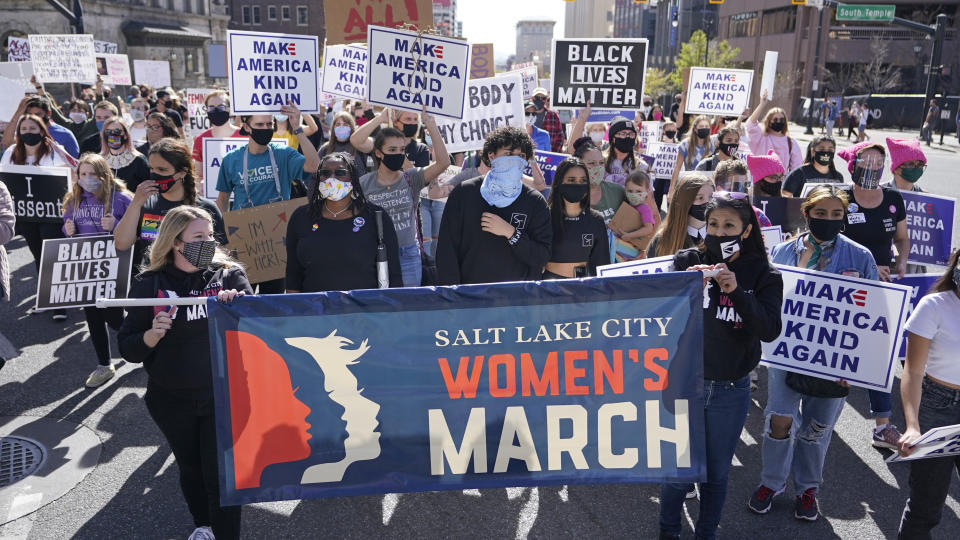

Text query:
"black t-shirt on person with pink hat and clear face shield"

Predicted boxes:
[[843, 187, 907, 266]]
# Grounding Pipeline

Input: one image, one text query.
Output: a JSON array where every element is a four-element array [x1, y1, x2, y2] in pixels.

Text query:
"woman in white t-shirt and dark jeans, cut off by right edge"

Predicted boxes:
[[898, 250, 960, 540]]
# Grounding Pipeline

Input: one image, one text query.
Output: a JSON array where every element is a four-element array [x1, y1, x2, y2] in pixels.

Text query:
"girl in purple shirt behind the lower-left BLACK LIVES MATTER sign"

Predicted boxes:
[[63, 154, 133, 388]]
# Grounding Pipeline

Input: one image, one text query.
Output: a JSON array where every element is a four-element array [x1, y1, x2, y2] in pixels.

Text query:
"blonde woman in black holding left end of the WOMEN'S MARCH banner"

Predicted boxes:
[[117, 205, 253, 540]]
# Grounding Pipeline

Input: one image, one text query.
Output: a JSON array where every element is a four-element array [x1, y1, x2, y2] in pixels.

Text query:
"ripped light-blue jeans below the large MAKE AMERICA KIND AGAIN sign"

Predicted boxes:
[[760, 367, 846, 494]]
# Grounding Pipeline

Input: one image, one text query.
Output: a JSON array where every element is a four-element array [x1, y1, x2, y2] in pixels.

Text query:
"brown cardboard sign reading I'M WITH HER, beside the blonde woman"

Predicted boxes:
[[223, 197, 307, 283]]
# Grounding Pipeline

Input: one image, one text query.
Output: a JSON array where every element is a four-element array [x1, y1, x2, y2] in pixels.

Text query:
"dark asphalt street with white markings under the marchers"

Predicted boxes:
[[0, 126, 960, 539]]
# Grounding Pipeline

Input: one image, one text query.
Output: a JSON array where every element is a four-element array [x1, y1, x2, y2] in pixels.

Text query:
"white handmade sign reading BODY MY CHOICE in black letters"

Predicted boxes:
[[436, 73, 524, 153]]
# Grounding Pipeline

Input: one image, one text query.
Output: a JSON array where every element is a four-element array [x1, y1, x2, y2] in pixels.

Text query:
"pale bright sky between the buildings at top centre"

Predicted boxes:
[[457, 0, 566, 61]]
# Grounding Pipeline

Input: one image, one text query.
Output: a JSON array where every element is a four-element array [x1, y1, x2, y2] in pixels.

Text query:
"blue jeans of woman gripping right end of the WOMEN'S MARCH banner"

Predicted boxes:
[[660, 375, 750, 539]]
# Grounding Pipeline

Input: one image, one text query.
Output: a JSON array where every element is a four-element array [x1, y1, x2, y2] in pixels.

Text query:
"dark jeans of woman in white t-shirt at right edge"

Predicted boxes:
[[897, 378, 960, 539]]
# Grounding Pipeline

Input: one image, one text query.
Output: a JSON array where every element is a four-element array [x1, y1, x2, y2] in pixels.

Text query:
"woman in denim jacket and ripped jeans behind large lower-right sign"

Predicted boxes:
[[747, 185, 877, 521]]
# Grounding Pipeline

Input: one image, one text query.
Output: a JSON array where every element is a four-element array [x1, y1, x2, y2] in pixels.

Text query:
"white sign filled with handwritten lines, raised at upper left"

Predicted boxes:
[[29, 34, 97, 84]]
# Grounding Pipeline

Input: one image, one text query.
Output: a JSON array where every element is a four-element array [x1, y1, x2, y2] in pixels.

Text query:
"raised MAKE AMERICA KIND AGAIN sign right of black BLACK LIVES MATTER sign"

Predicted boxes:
[[685, 67, 753, 116]]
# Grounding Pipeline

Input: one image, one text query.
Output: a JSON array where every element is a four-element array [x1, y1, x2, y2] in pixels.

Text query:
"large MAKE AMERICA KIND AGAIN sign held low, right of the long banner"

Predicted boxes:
[[761, 264, 910, 392]]
